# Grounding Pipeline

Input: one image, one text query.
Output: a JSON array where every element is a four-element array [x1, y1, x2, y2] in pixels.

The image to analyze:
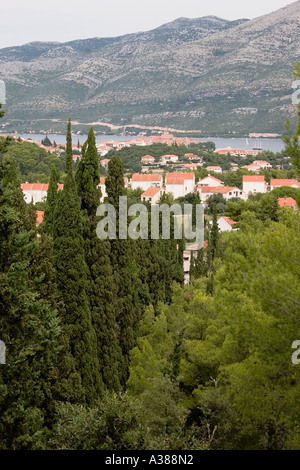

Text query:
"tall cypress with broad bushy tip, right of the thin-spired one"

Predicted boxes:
[[76, 128, 121, 390]]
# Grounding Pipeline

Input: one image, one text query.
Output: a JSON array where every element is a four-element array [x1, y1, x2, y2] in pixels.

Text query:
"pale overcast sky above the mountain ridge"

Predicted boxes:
[[0, 0, 294, 48]]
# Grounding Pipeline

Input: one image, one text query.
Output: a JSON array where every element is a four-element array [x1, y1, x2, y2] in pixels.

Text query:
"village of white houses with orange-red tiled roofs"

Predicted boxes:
[[2, 134, 300, 232]]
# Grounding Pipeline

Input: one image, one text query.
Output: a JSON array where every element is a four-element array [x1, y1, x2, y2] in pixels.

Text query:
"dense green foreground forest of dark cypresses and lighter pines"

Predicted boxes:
[[0, 85, 300, 450]]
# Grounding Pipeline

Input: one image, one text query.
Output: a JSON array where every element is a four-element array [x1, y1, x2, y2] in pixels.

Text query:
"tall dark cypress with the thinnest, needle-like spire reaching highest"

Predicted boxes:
[[53, 120, 102, 403]]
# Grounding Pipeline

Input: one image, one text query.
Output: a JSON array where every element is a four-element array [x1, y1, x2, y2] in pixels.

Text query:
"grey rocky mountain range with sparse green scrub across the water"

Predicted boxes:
[[0, 1, 300, 136]]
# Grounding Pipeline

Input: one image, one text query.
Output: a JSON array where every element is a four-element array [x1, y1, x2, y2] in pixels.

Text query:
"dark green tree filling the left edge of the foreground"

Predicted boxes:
[[0, 157, 60, 449]]
